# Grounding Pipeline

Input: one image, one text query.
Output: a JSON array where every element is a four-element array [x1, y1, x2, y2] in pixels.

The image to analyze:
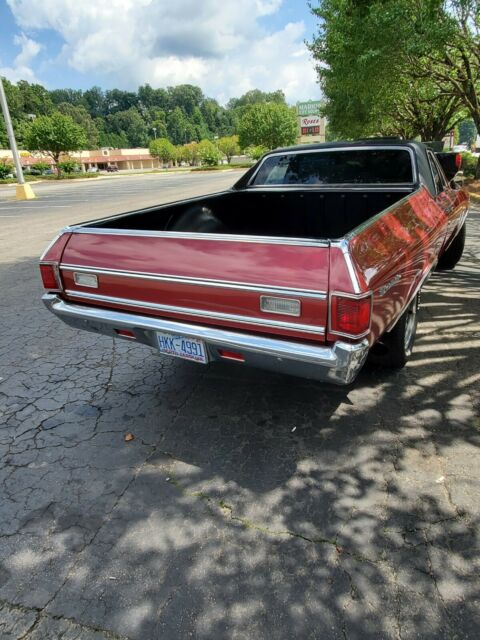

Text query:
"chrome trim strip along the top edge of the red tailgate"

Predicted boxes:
[[65, 225, 330, 247]]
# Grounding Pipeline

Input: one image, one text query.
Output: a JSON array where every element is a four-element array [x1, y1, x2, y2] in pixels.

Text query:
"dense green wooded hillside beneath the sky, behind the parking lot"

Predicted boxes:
[[0, 80, 300, 148]]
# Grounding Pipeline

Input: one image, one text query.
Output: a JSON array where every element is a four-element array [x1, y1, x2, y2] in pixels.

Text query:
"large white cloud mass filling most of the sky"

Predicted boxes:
[[7, 0, 319, 101]]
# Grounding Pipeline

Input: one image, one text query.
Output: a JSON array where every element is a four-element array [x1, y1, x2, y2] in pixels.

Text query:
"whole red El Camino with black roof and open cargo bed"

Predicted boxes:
[[40, 139, 468, 384]]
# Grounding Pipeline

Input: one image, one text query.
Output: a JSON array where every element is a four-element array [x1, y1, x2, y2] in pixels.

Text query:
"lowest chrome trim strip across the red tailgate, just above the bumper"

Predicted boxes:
[[65, 289, 325, 335]]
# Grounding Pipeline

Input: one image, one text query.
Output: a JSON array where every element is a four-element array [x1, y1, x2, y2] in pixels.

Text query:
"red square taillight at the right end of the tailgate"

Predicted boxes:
[[330, 293, 372, 338]]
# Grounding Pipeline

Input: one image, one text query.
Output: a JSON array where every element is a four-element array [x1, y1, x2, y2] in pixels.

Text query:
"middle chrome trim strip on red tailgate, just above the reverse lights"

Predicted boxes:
[[60, 263, 327, 300]]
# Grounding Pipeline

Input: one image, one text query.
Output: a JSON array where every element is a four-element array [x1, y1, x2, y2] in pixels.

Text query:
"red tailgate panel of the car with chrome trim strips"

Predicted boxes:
[[60, 228, 329, 341]]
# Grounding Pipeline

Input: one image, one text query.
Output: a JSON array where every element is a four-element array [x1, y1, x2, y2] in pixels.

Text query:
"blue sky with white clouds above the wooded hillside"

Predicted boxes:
[[0, 0, 320, 104]]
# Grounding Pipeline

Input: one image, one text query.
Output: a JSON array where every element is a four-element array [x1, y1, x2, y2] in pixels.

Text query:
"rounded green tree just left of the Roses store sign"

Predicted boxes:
[[238, 102, 297, 149]]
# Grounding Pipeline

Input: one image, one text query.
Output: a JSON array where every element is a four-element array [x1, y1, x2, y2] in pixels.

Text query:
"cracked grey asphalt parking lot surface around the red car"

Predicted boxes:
[[0, 173, 480, 640]]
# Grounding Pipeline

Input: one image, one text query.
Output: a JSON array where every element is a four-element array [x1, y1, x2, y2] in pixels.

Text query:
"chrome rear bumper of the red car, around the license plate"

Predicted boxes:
[[43, 293, 368, 384]]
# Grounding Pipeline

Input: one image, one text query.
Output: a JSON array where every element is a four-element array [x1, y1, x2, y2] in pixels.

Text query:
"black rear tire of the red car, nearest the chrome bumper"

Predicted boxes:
[[370, 294, 419, 369]]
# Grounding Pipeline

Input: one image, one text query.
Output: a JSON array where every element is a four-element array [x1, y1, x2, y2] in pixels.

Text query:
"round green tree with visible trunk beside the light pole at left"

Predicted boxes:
[[26, 112, 87, 176]]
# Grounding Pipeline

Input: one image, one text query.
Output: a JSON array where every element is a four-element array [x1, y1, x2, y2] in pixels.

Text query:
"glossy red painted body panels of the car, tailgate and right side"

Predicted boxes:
[[42, 182, 468, 344]]
